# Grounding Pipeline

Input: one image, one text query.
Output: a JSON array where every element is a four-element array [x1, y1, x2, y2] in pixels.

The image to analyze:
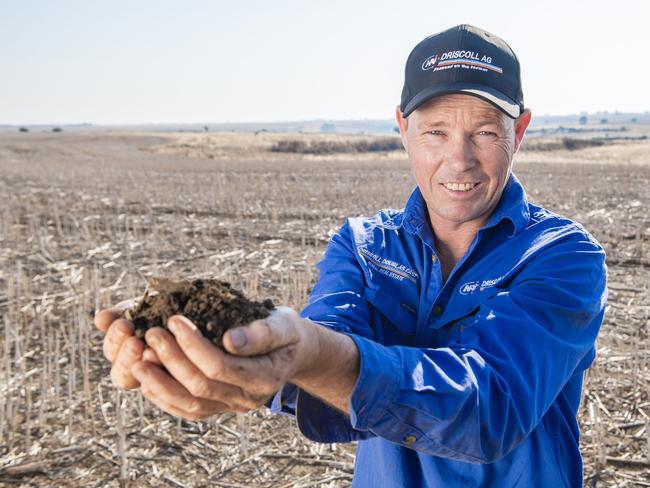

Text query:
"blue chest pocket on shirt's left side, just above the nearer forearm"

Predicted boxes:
[[364, 288, 417, 344]]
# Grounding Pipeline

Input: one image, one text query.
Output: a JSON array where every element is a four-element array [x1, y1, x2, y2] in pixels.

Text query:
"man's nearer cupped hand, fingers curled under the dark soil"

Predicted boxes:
[[122, 307, 318, 420]]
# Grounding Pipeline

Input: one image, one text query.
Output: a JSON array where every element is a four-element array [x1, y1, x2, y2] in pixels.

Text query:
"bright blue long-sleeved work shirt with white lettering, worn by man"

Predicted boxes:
[[271, 174, 607, 487]]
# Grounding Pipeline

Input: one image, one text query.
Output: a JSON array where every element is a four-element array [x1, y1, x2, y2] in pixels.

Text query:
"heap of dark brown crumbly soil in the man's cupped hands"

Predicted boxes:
[[125, 277, 274, 347]]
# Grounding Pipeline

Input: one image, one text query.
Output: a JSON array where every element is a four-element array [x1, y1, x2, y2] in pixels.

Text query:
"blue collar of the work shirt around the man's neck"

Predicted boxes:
[[403, 173, 530, 238]]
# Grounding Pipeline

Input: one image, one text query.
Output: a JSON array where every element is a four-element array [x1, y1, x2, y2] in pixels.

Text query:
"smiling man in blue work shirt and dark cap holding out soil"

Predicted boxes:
[[96, 25, 606, 487]]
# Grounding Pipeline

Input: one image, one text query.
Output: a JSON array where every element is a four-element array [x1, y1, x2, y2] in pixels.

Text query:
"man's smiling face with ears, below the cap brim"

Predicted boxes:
[[397, 94, 530, 228]]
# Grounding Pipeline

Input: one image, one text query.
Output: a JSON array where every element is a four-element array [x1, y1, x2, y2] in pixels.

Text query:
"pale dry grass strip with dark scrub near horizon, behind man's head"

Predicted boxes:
[[142, 125, 650, 164]]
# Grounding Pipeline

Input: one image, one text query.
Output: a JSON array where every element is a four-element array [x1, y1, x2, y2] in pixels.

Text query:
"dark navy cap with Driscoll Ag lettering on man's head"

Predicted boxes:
[[400, 24, 524, 118]]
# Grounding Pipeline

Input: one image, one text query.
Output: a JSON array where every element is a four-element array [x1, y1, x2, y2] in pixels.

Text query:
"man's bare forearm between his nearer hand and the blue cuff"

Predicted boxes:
[[291, 319, 359, 414]]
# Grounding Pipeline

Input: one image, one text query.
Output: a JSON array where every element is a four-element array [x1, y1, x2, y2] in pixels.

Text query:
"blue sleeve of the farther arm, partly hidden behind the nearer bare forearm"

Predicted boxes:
[[267, 220, 375, 442]]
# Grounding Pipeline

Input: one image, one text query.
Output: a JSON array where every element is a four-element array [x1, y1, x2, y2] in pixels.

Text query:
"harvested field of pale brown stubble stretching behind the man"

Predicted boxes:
[[0, 133, 650, 487]]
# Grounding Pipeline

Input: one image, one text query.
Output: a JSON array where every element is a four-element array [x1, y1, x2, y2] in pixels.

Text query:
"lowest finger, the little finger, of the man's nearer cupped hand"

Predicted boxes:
[[132, 361, 228, 420]]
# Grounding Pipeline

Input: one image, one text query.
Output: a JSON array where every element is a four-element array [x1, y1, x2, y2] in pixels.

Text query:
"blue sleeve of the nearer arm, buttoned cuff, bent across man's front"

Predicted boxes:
[[350, 237, 607, 463]]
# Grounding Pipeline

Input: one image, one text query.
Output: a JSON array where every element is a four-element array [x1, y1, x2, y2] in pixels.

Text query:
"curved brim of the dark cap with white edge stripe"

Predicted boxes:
[[402, 83, 521, 119]]
